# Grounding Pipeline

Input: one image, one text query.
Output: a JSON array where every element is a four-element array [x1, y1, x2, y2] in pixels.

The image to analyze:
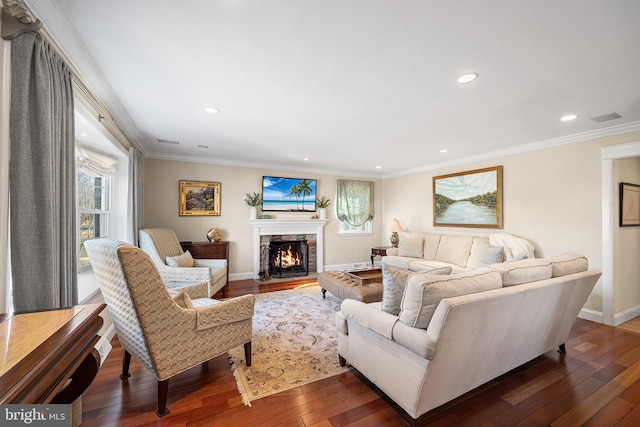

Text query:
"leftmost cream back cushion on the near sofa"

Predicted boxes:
[[398, 269, 502, 329]]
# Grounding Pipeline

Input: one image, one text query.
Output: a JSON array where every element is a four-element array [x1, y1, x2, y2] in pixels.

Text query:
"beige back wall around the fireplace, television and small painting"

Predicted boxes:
[[144, 159, 382, 279]]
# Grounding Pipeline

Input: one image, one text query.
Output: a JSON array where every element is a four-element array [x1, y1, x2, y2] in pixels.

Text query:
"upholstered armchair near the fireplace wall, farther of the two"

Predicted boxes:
[[138, 228, 228, 297]]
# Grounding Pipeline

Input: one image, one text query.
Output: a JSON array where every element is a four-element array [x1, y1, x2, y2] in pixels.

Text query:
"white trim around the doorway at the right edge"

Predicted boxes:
[[601, 141, 640, 326]]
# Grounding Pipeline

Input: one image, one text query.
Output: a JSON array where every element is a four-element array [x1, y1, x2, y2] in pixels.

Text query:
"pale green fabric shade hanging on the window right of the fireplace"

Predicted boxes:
[[336, 179, 374, 227]]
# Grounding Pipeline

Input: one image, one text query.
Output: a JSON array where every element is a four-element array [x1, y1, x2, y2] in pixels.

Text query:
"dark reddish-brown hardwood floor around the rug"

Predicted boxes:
[[82, 280, 640, 427]]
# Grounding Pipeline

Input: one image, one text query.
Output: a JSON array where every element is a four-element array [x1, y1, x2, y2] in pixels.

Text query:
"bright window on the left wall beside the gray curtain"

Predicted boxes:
[[77, 169, 110, 267]]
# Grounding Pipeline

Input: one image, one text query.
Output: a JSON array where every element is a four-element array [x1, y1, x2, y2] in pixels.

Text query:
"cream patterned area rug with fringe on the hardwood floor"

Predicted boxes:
[[229, 283, 350, 406]]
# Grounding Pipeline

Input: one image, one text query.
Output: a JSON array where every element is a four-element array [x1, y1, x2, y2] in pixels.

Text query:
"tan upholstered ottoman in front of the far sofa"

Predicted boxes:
[[318, 269, 382, 303]]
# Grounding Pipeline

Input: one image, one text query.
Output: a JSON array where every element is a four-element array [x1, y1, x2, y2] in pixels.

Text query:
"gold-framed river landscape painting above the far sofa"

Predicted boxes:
[[433, 166, 502, 228]]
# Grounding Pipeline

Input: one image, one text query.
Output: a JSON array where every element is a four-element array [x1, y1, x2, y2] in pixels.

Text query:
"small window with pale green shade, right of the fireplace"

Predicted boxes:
[[336, 179, 373, 235]]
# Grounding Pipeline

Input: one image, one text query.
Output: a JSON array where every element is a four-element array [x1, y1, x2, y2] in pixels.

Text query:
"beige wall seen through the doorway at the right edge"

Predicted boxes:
[[613, 157, 640, 313]]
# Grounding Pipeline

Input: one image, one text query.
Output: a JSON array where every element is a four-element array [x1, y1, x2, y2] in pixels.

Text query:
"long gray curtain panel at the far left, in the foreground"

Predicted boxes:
[[9, 32, 78, 311]]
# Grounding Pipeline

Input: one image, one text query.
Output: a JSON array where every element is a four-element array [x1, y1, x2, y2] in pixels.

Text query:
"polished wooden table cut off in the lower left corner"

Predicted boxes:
[[0, 304, 106, 404]]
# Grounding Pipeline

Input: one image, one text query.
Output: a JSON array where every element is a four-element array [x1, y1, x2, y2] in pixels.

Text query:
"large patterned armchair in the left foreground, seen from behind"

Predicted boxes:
[[85, 239, 254, 417]]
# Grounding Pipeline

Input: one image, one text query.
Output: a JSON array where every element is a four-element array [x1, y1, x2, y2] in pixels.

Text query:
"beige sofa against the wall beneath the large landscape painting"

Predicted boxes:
[[382, 232, 534, 273]]
